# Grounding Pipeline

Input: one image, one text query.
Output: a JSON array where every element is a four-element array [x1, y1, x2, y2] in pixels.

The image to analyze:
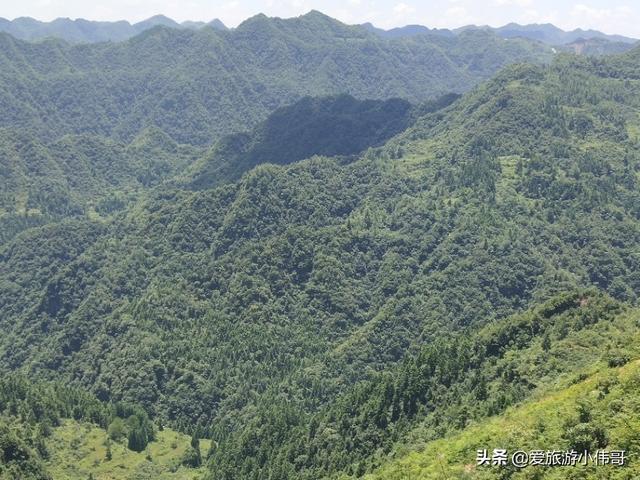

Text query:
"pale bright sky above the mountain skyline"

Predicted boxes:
[[0, 0, 640, 38]]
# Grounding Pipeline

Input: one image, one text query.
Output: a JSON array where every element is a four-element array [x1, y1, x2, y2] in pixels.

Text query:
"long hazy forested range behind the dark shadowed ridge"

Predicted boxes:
[[0, 12, 553, 144]]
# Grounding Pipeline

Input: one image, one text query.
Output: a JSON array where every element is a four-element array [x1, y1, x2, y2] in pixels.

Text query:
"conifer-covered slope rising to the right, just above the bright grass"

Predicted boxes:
[[208, 292, 640, 479]]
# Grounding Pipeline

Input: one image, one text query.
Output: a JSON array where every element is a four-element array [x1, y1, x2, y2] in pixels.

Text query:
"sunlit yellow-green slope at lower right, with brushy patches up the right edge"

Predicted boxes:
[[365, 310, 640, 480]]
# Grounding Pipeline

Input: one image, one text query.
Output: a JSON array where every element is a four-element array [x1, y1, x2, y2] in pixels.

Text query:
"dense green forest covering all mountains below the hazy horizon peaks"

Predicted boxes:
[[0, 12, 640, 480]]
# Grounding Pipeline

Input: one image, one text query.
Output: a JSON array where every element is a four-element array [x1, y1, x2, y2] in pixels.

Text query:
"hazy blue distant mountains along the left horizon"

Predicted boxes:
[[0, 15, 227, 43]]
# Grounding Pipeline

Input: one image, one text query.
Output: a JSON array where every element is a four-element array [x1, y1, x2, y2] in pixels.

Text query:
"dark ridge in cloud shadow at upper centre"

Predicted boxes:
[[182, 95, 420, 189]]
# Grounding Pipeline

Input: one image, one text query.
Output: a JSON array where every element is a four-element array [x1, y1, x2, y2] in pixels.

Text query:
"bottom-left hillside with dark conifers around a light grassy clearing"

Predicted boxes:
[[0, 375, 210, 480]]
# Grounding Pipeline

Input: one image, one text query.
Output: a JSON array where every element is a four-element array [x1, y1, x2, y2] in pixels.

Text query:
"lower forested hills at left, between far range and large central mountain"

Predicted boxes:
[[0, 127, 202, 244]]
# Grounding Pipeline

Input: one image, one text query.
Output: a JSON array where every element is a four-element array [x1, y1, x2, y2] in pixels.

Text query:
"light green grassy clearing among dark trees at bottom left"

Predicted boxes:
[[47, 420, 210, 480]]
